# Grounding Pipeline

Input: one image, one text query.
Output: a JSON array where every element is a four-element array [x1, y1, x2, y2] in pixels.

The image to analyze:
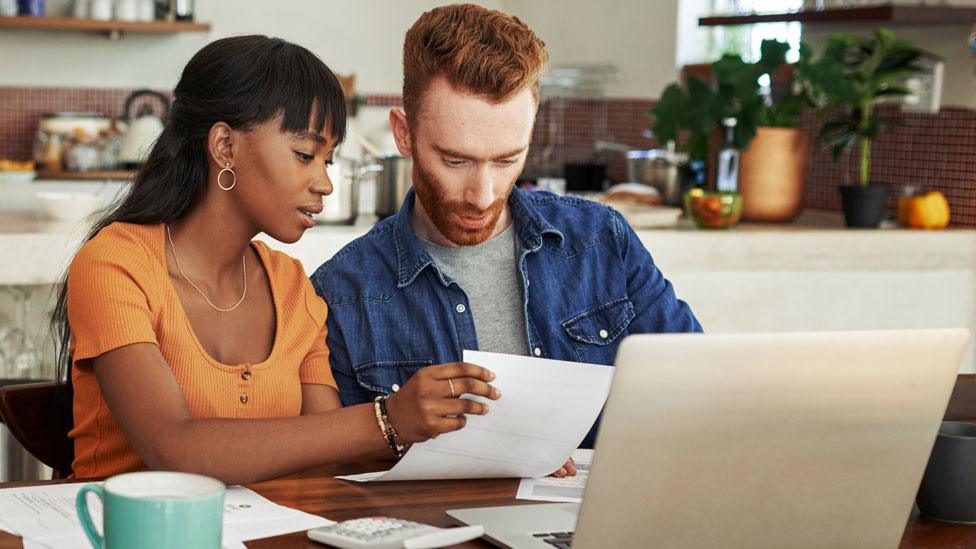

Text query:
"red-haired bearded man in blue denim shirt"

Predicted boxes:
[[312, 5, 701, 446]]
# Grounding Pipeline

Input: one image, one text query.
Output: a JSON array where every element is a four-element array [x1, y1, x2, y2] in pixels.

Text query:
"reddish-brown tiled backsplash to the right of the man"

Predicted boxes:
[[527, 99, 976, 227]]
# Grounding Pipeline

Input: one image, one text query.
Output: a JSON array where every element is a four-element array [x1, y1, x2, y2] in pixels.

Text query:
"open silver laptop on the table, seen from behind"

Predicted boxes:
[[448, 329, 969, 549]]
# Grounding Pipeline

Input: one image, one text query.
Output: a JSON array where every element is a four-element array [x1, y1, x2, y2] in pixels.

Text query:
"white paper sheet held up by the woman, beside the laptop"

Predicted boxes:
[[338, 351, 613, 482]]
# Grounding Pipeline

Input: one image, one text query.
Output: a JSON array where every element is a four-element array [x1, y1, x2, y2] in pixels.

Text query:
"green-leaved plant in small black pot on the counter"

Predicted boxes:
[[817, 28, 936, 227]]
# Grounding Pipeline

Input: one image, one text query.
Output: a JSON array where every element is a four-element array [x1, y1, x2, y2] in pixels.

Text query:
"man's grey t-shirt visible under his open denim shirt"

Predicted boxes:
[[420, 225, 529, 355]]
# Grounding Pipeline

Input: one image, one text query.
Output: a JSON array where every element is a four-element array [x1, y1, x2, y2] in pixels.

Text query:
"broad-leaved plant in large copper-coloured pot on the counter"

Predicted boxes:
[[651, 40, 844, 221]]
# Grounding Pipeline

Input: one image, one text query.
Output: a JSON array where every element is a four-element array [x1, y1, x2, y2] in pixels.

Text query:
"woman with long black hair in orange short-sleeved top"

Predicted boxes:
[[55, 36, 499, 483]]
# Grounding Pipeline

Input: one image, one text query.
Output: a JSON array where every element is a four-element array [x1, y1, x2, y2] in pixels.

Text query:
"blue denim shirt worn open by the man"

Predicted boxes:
[[311, 188, 701, 446]]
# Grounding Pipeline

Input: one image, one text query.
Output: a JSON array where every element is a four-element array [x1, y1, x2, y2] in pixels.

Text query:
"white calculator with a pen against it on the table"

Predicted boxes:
[[308, 517, 485, 549]]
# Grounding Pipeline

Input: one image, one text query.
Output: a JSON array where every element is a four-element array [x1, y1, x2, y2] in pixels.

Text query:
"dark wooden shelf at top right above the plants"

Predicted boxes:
[[698, 4, 976, 27]]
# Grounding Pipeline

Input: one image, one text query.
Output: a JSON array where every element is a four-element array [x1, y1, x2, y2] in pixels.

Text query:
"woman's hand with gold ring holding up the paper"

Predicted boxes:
[[386, 362, 501, 445]]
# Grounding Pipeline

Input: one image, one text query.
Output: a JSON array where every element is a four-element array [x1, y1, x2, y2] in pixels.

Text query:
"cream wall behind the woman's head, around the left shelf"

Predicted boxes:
[[0, 0, 499, 93]]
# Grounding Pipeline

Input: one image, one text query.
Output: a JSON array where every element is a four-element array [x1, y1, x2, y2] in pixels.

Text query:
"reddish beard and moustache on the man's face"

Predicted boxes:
[[413, 149, 514, 246]]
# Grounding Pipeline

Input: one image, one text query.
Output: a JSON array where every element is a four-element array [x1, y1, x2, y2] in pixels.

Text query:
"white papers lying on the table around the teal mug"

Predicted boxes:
[[0, 484, 334, 549]]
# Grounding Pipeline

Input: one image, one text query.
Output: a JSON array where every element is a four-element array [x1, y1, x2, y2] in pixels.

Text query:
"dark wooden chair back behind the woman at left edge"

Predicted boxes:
[[0, 381, 75, 478]]
